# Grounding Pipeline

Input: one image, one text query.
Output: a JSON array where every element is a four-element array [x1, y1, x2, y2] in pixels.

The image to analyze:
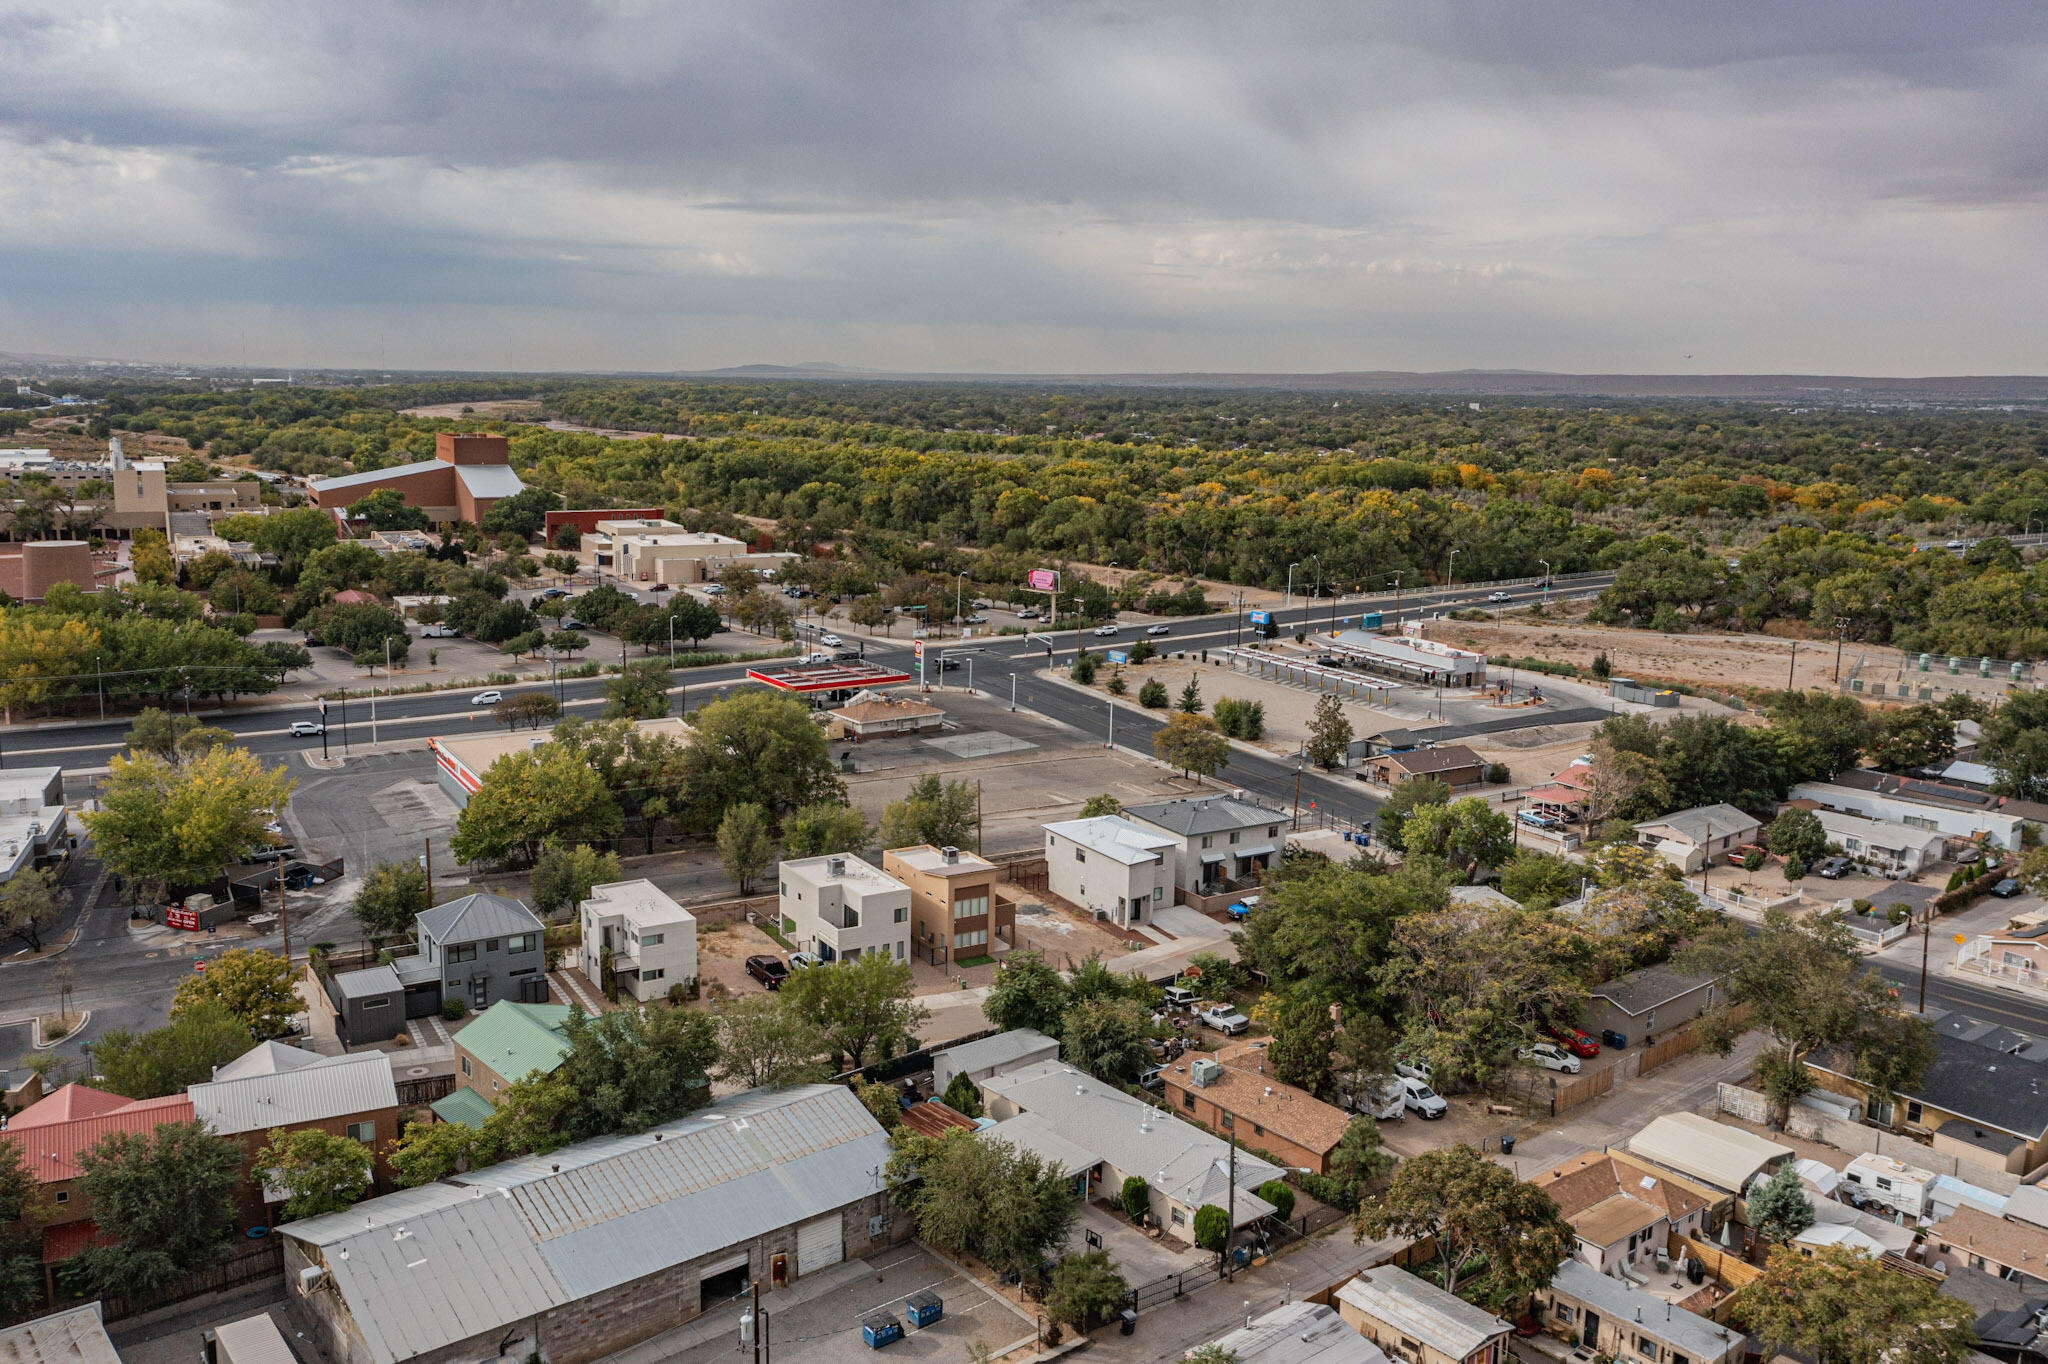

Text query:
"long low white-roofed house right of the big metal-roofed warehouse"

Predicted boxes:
[[981, 1061, 1284, 1243]]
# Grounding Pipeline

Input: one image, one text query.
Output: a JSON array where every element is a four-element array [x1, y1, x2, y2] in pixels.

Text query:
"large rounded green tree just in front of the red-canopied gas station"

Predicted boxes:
[[684, 690, 846, 829]]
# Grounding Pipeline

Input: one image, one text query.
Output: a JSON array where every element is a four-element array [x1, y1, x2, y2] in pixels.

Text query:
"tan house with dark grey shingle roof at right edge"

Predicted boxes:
[[1806, 1014, 2048, 1174]]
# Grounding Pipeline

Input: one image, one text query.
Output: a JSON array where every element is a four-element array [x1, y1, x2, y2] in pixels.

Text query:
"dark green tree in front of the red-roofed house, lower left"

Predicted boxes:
[[72, 1122, 242, 1294]]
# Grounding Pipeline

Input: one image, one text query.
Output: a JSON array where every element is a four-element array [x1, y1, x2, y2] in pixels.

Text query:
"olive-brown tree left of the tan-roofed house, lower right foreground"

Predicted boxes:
[[1356, 1141, 1577, 1296]]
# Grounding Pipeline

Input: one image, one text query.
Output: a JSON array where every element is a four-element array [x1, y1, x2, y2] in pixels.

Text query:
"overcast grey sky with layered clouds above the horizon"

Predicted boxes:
[[0, 0, 2048, 375]]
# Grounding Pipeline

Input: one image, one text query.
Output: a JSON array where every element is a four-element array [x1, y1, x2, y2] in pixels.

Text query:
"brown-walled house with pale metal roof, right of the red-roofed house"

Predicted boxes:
[[186, 1042, 399, 1223]]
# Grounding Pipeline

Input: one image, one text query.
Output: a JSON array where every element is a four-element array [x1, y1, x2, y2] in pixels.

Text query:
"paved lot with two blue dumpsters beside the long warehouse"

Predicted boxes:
[[651, 1243, 1036, 1364]]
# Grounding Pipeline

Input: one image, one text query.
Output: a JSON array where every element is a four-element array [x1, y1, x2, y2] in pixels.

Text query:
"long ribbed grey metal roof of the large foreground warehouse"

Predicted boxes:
[[279, 1085, 889, 1364]]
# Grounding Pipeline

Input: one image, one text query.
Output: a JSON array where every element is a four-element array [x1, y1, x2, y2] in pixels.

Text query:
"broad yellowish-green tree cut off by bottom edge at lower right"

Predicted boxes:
[[1733, 1245, 1976, 1364]]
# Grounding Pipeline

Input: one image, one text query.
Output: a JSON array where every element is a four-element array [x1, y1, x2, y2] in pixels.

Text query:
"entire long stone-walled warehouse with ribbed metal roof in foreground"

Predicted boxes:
[[279, 1085, 911, 1364]]
